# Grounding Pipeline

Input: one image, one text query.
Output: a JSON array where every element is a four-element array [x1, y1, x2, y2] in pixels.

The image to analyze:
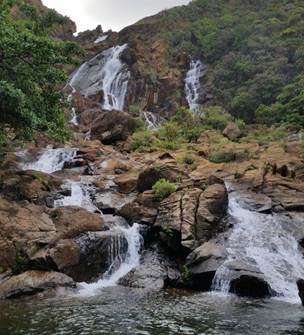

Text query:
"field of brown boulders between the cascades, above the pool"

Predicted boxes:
[[0, 127, 304, 298]]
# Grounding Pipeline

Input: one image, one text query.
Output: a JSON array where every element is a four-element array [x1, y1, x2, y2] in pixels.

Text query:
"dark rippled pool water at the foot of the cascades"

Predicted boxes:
[[0, 287, 304, 335]]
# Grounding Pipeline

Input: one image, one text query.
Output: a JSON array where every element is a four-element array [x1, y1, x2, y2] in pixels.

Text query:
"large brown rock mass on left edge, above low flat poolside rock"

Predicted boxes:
[[0, 198, 103, 271]]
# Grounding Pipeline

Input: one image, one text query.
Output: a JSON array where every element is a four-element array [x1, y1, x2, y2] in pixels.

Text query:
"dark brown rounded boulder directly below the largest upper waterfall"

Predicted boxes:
[[91, 111, 136, 144]]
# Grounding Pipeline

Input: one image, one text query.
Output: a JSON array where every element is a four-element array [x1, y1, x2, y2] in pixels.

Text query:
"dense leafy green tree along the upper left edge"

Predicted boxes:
[[0, 0, 80, 145]]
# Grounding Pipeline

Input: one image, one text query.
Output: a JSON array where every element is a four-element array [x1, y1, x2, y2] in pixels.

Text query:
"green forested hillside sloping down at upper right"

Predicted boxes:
[[145, 0, 304, 126]]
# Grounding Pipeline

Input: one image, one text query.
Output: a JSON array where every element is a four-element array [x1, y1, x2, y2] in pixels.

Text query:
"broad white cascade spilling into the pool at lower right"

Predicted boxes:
[[212, 188, 304, 303]]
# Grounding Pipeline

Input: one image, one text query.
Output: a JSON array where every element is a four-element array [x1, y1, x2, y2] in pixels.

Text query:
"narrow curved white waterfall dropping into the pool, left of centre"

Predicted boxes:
[[79, 223, 142, 296]]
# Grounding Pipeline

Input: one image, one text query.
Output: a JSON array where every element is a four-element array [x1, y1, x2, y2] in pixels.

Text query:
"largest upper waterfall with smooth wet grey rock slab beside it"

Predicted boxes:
[[69, 44, 130, 111]]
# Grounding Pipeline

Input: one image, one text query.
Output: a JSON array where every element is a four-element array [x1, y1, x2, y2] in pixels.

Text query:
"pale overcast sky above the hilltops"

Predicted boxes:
[[42, 0, 190, 32]]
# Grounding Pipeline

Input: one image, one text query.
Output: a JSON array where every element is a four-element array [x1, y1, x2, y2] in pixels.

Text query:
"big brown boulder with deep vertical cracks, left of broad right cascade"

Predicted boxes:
[[155, 184, 228, 252]]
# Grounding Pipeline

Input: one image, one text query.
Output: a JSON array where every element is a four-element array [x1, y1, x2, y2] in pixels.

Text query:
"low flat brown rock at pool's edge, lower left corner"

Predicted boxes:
[[0, 271, 75, 299]]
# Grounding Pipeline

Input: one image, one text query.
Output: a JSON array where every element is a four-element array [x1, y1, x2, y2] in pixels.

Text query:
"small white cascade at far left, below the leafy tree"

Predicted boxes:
[[22, 148, 77, 173]]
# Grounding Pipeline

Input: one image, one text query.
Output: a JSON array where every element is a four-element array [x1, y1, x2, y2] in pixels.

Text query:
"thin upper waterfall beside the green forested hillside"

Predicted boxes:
[[185, 60, 204, 112]]
